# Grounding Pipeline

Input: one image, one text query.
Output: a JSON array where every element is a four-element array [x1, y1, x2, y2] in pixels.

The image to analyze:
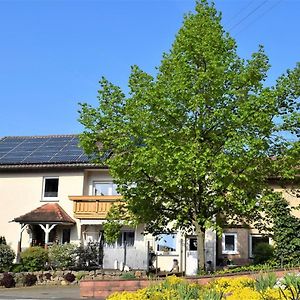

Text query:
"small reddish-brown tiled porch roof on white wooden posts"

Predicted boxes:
[[13, 203, 75, 224]]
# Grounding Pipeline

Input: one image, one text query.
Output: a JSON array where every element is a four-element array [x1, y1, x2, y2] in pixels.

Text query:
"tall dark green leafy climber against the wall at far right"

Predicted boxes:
[[268, 195, 300, 265]]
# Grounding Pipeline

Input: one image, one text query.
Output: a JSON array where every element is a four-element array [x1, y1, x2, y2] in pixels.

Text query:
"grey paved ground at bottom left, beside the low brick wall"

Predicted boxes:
[[0, 285, 80, 300]]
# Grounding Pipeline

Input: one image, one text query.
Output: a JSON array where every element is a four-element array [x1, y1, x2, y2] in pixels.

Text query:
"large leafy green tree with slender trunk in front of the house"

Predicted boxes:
[[80, 1, 300, 268]]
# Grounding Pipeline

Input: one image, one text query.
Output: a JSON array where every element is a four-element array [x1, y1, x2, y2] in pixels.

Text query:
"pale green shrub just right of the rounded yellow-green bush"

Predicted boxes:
[[48, 244, 77, 270]]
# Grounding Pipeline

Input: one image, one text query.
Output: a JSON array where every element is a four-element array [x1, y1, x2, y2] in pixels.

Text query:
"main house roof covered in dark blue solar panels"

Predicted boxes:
[[0, 135, 94, 169]]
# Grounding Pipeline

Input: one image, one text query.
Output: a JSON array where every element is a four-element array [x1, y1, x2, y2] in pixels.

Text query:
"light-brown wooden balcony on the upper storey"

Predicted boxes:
[[69, 196, 122, 219]]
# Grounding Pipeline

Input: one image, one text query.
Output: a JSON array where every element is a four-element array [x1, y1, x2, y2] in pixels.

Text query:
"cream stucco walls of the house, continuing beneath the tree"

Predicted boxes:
[[0, 162, 299, 275]]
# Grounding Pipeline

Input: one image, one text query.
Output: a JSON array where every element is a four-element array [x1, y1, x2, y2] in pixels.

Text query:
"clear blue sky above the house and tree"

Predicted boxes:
[[0, 0, 300, 136]]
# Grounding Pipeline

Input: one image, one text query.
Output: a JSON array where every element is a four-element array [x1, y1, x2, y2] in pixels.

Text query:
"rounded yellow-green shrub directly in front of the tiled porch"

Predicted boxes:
[[21, 247, 48, 272]]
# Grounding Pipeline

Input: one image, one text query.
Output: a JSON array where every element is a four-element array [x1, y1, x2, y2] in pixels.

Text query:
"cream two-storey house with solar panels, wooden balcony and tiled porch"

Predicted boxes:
[[0, 135, 300, 275]]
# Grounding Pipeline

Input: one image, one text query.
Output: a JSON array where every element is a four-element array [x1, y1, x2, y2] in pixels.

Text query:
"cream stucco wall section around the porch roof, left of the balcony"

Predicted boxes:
[[0, 170, 84, 251]]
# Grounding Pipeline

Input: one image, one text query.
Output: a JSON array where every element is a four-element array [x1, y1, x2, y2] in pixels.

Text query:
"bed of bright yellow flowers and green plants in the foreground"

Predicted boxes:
[[108, 273, 300, 300]]
